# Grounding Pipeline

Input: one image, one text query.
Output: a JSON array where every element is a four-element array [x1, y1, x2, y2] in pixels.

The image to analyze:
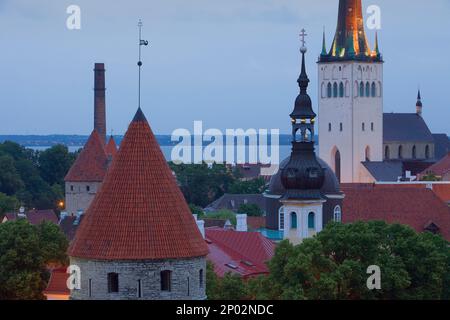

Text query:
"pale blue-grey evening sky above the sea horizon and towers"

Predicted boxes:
[[0, 0, 450, 134]]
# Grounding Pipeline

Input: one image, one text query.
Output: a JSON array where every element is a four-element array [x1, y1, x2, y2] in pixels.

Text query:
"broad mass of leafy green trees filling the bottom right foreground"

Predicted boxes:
[[250, 222, 450, 300]]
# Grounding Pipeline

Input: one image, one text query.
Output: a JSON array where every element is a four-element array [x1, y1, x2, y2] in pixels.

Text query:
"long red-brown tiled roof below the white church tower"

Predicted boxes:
[[342, 184, 450, 241]]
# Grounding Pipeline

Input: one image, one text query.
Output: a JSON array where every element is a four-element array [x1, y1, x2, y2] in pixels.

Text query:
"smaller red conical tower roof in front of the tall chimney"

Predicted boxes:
[[64, 130, 108, 182]]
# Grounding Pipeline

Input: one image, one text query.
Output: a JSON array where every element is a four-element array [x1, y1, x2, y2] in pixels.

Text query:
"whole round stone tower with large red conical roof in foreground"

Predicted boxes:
[[69, 108, 208, 300]]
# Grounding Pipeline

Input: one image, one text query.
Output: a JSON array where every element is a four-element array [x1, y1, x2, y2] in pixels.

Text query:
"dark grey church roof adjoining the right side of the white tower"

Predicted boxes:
[[383, 113, 434, 143]]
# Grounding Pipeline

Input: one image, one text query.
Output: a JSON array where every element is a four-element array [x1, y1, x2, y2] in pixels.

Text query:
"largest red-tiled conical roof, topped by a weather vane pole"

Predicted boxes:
[[69, 109, 208, 260]]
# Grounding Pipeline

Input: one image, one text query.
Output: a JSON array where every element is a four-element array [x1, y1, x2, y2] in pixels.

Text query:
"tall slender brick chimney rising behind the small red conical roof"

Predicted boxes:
[[94, 63, 106, 144]]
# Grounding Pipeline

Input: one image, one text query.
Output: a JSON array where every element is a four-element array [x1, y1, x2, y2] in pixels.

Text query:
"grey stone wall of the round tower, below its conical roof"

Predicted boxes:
[[70, 257, 206, 300]]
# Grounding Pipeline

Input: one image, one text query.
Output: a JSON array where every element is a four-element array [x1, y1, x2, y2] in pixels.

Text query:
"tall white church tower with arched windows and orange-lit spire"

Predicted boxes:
[[318, 0, 383, 183]]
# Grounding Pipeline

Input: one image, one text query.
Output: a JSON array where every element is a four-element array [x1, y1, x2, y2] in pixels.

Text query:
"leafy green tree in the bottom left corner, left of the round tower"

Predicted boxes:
[[0, 219, 68, 300]]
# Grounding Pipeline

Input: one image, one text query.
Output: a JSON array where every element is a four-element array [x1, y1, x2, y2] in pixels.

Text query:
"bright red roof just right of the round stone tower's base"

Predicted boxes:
[[205, 228, 275, 278]]
